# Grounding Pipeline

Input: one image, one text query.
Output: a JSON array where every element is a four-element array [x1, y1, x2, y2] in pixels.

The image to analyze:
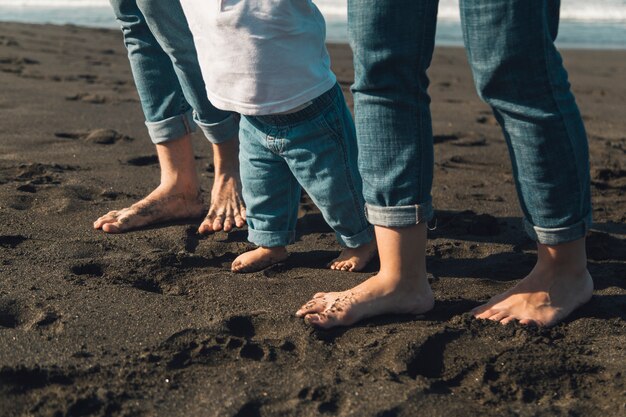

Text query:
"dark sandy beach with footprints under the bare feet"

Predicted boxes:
[[0, 23, 626, 417]]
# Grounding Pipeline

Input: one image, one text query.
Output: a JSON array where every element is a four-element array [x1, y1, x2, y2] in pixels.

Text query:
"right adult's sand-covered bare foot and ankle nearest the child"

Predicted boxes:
[[296, 223, 435, 328]]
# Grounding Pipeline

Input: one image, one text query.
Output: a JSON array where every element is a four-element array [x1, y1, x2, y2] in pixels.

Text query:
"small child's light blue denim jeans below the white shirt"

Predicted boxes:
[[239, 85, 374, 248]]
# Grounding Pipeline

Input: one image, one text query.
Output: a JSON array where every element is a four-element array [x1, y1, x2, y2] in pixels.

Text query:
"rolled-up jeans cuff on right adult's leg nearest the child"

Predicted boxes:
[[365, 200, 434, 227]]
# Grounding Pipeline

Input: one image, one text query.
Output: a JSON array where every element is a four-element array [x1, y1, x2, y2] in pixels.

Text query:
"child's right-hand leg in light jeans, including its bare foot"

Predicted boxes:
[[278, 85, 376, 271]]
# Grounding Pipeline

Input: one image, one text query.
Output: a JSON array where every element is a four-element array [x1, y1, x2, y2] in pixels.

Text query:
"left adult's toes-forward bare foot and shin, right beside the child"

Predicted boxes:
[[198, 138, 246, 234]]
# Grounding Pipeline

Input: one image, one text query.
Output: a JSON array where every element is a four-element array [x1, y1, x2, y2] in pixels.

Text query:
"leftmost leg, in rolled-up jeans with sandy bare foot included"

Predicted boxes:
[[94, 0, 203, 233]]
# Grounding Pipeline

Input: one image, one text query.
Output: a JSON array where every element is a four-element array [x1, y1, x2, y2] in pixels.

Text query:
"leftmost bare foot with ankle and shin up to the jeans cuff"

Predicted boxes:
[[93, 135, 203, 233]]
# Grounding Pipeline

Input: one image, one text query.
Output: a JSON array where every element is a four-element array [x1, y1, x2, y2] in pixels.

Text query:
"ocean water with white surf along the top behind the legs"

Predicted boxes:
[[0, 0, 626, 49]]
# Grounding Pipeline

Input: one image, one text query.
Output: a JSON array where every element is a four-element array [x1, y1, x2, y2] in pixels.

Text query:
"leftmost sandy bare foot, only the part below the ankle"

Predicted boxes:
[[93, 185, 203, 233]]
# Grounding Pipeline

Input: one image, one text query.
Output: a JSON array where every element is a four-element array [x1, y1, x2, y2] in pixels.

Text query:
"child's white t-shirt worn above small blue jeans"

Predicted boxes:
[[181, 0, 336, 115]]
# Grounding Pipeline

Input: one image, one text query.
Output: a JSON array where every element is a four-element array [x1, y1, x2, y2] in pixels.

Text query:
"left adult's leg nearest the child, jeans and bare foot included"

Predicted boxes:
[[137, 0, 246, 233]]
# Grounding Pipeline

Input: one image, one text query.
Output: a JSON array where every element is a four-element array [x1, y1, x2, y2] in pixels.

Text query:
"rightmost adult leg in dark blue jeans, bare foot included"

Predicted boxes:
[[461, 0, 593, 326]]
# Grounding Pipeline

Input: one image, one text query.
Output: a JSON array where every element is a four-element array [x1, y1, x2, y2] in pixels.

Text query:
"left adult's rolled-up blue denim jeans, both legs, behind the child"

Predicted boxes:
[[110, 0, 239, 144]]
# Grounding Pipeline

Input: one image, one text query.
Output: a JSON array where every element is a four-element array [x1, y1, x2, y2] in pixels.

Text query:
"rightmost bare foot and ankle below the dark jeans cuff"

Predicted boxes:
[[472, 239, 593, 327]]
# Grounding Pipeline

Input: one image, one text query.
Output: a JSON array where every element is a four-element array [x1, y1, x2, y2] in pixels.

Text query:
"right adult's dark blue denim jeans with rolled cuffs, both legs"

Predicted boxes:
[[348, 0, 591, 245]]
